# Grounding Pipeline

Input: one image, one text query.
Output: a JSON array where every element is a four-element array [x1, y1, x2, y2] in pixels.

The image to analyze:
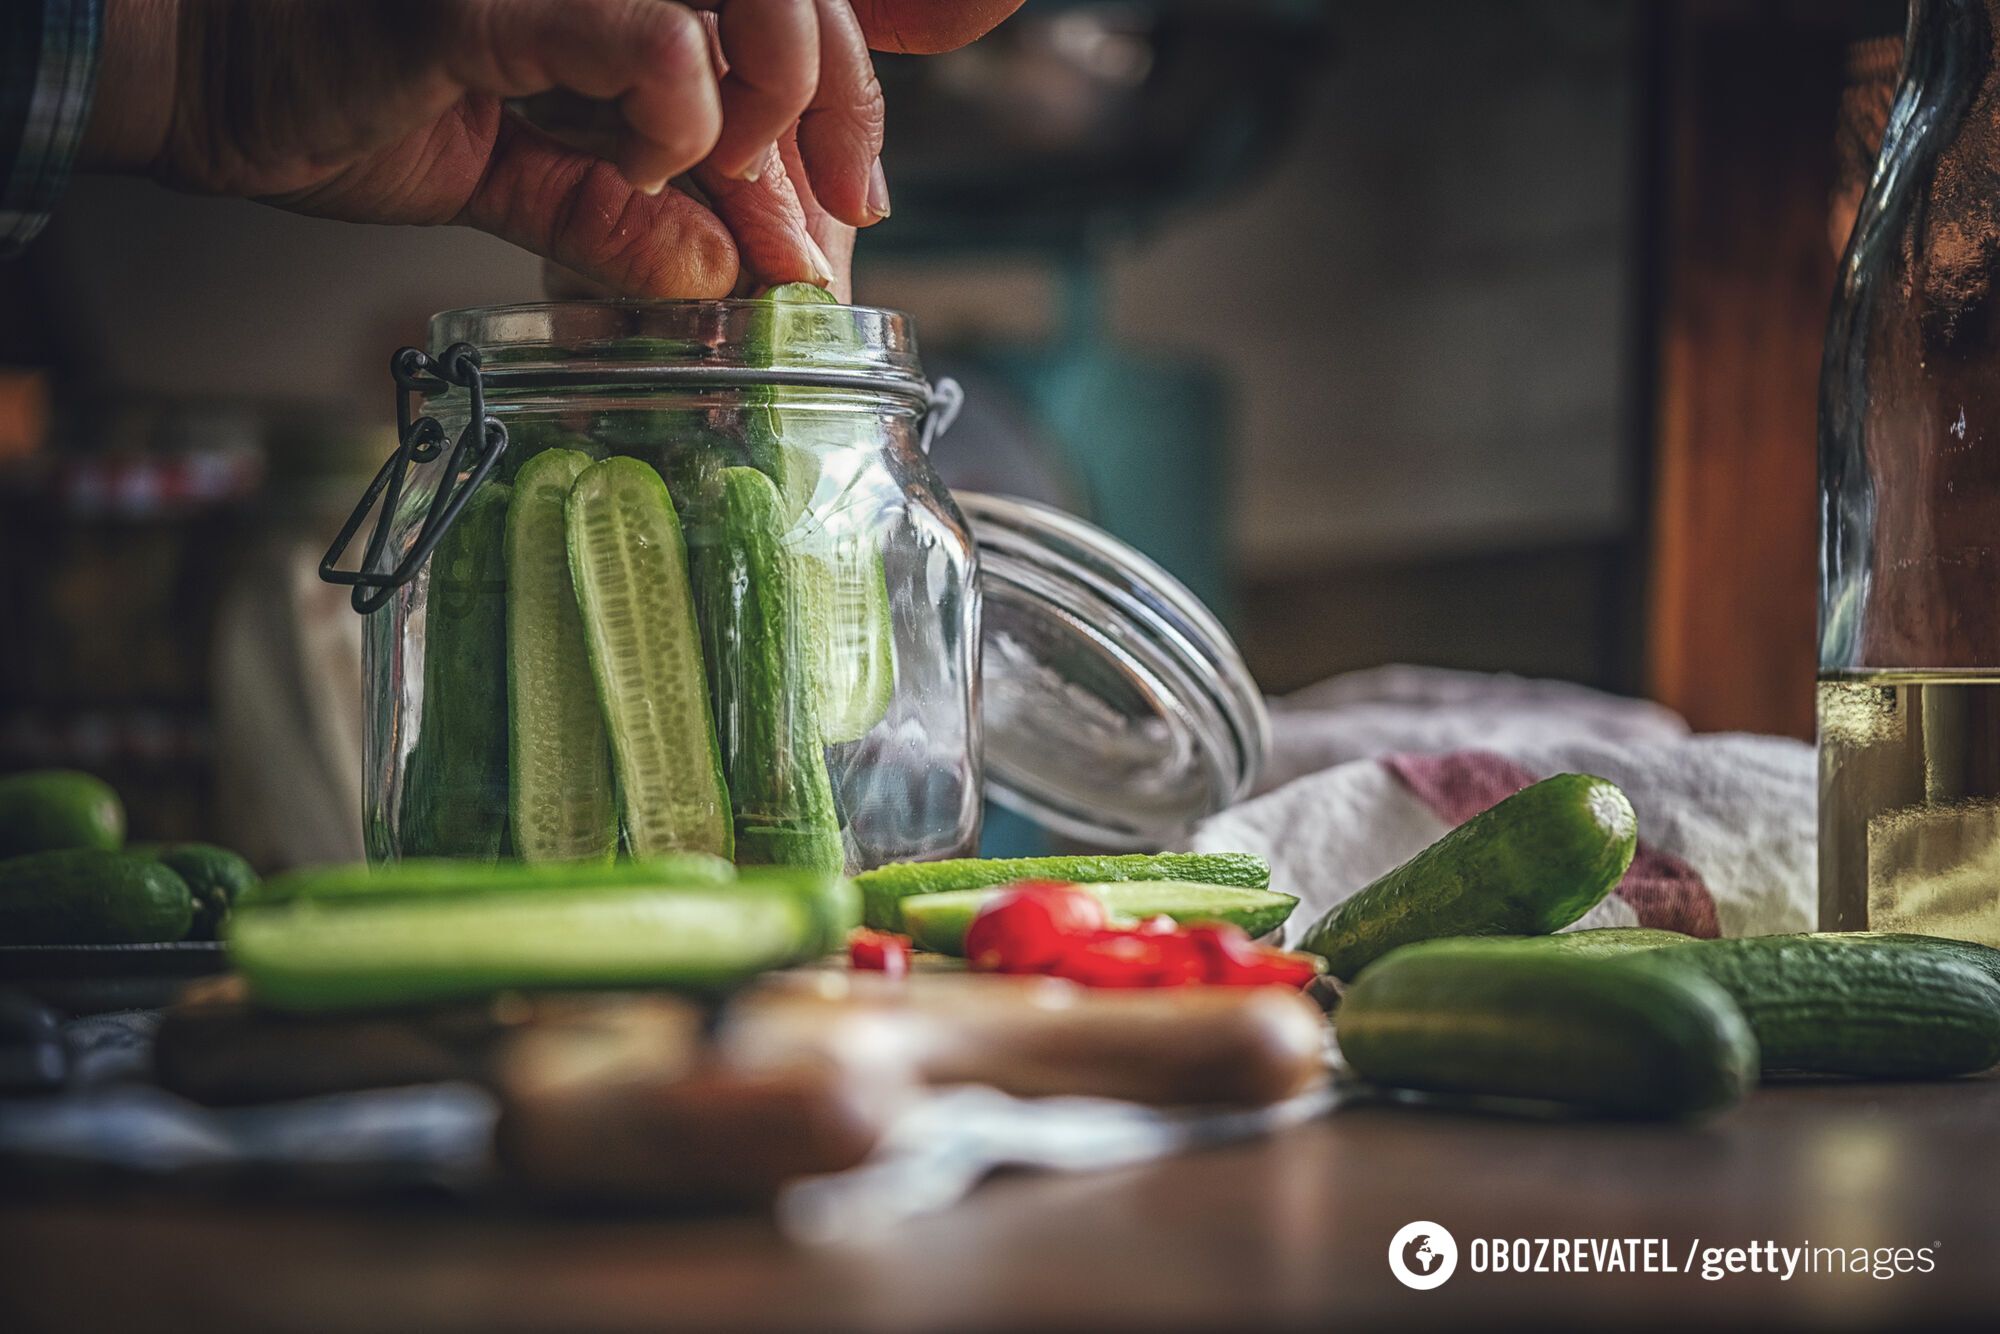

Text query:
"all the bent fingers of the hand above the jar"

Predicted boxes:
[[446, 0, 912, 296]]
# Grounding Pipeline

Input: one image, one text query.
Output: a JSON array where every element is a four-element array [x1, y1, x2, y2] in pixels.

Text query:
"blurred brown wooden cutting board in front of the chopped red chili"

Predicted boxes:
[[156, 968, 1326, 1202]]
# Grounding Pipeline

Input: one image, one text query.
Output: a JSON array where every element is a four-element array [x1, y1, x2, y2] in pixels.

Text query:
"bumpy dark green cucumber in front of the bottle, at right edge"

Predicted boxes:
[[1644, 936, 2000, 1080]]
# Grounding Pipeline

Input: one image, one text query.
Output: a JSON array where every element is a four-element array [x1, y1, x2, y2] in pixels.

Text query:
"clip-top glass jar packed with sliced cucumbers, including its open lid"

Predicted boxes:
[[322, 300, 1268, 870]]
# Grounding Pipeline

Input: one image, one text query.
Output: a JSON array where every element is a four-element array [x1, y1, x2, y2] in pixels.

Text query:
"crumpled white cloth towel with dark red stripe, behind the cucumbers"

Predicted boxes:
[[1190, 666, 1816, 940]]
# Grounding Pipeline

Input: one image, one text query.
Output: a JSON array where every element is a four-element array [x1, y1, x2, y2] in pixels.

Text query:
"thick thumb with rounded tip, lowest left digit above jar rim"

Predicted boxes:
[[458, 116, 744, 298]]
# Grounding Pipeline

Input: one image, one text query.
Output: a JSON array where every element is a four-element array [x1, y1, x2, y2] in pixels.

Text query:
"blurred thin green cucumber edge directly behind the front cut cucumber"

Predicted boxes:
[[248, 852, 736, 908]]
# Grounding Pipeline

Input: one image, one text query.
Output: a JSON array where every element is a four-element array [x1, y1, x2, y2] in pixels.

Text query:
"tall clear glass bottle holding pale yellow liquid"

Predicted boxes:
[[1818, 0, 2000, 944]]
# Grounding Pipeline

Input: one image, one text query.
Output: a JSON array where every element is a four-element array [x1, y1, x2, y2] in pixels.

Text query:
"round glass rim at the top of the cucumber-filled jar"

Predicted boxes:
[[430, 298, 930, 404]]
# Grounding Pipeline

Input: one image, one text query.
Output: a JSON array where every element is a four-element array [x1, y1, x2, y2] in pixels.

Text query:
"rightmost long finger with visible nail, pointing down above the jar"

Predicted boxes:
[[794, 0, 888, 226]]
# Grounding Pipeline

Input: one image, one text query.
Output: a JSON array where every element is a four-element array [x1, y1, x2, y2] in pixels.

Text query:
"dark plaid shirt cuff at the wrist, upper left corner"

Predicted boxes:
[[0, 0, 104, 256]]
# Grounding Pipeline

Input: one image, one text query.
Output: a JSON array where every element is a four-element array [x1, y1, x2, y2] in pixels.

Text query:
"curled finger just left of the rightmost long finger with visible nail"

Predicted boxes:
[[692, 0, 820, 180]]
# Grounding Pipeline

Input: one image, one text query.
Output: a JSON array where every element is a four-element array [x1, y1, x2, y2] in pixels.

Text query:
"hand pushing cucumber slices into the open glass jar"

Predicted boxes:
[[84, 0, 1020, 296]]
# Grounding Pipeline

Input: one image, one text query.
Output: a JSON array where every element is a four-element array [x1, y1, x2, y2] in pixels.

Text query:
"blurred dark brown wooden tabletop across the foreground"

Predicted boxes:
[[0, 1078, 2000, 1334]]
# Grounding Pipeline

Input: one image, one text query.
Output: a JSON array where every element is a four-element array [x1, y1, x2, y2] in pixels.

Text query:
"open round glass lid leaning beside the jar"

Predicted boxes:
[[958, 492, 1270, 848]]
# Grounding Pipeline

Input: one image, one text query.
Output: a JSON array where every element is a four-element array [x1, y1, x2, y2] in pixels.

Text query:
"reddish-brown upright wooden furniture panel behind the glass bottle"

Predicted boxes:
[[1646, 0, 1900, 738]]
